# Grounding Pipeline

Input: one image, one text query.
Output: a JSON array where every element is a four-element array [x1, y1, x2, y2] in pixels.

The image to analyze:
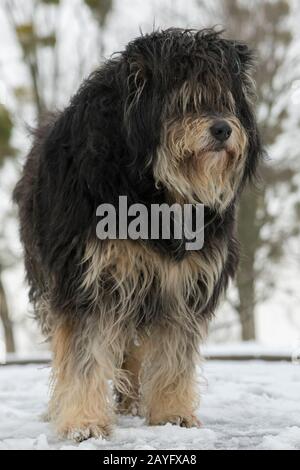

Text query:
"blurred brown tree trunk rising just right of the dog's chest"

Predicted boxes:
[[237, 188, 259, 341]]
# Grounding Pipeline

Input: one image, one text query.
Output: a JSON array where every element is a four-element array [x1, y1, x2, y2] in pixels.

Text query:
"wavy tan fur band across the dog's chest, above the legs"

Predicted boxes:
[[82, 240, 227, 326]]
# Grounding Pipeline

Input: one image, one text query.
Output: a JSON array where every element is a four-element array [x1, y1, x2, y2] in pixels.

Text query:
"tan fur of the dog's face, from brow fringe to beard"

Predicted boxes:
[[154, 82, 247, 212]]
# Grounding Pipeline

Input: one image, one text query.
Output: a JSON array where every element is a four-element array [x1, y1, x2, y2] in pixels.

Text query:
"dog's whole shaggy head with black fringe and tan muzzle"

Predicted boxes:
[[125, 30, 261, 211]]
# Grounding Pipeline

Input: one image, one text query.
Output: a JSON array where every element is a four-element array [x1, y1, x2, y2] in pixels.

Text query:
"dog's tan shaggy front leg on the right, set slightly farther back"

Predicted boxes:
[[141, 326, 201, 427]]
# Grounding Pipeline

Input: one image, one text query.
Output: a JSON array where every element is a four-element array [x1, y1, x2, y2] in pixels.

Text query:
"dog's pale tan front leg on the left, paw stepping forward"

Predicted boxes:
[[49, 322, 114, 441]]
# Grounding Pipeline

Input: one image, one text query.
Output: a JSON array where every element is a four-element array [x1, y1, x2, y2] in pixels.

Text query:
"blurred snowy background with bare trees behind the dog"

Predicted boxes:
[[0, 0, 300, 355]]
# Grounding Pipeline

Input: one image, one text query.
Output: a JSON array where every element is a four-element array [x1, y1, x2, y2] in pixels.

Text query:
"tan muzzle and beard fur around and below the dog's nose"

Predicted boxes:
[[154, 116, 247, 211]]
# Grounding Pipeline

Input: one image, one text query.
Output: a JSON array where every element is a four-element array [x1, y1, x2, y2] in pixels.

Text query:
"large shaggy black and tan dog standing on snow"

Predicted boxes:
[[14, 29, 262, 441]]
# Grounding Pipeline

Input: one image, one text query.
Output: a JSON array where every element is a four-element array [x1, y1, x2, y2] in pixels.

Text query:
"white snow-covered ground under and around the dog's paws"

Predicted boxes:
[[0, 361, 300, 450]]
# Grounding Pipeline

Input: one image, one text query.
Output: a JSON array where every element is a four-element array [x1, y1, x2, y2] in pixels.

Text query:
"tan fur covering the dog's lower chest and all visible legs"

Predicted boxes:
[[50, 240, 227, 440]]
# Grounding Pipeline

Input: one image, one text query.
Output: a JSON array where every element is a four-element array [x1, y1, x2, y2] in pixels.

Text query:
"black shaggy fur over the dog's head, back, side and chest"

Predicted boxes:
[[14, 29, 262, 321]]
